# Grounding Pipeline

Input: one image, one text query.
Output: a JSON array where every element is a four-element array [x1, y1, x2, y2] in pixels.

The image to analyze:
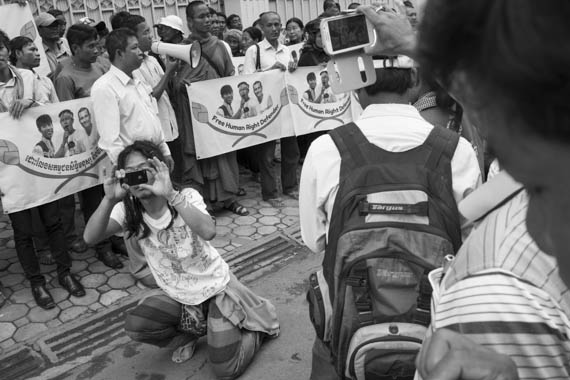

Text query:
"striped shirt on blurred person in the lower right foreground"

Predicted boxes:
[[432, 192, 570, 380]]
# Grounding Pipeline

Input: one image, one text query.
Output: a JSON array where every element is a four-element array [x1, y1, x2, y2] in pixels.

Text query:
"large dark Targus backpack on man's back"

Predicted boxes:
[[307, 123, 461, 380]]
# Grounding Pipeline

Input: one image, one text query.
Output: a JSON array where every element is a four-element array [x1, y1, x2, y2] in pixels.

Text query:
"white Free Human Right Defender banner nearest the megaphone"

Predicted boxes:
[[187, 70, 294, 159]]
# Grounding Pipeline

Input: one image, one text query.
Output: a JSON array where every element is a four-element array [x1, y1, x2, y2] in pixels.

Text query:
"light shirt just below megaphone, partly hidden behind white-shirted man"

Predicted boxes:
[[133, 55, 178, 141]]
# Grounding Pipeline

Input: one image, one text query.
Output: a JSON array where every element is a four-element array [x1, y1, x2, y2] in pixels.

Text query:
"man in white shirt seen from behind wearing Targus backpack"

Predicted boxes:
[[299, 57, 481, 380]]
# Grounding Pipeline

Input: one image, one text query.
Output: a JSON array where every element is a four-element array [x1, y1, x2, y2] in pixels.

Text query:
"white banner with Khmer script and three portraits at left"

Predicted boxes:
[[0, 98, 112, 213]]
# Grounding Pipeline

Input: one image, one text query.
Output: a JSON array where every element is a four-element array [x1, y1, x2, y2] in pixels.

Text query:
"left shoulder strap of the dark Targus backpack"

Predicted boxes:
[[329, 123, 370, 167]]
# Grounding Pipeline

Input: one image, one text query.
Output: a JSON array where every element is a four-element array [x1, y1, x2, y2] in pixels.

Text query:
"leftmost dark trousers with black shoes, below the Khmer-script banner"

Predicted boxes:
[[9, 201, 71, 286]]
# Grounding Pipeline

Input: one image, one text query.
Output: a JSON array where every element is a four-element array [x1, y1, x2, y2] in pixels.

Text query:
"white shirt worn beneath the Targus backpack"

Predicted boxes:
[[299, 104, 481, 252]]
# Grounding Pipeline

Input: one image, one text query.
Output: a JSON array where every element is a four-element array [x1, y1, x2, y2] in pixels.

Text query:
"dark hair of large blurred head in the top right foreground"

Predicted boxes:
[[418, 0, 570, 142]]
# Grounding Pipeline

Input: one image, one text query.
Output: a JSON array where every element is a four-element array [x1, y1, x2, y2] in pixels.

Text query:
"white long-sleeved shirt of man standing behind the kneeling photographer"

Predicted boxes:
[[91, 66, 170, 163]]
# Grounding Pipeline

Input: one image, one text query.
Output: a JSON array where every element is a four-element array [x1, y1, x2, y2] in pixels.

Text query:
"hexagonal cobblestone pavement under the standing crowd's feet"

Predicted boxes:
[[0, 167, 299, 353]]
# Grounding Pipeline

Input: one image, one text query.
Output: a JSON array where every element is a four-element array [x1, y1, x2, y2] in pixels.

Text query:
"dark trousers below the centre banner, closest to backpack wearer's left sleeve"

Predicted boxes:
[[256, 136, 299, 200]]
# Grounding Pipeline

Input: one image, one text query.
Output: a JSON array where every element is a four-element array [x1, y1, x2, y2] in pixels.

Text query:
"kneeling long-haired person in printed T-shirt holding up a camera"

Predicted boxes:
[[84, 141, 279, 379]]
